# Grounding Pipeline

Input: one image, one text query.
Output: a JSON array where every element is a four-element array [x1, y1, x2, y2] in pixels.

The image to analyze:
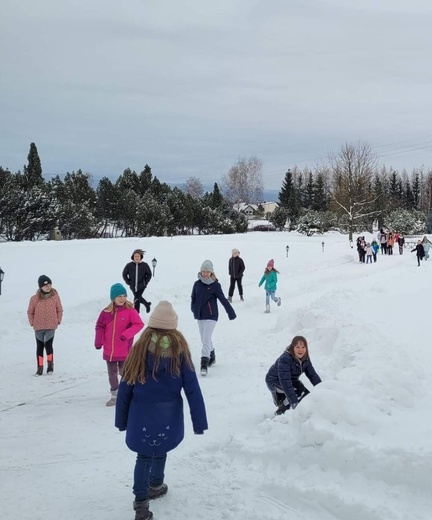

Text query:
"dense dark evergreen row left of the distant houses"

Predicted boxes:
[[0, 143, 247, 241]]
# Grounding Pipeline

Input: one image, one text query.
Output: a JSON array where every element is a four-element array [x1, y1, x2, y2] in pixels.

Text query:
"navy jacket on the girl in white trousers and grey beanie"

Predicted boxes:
[[191, 280, 237, 321]]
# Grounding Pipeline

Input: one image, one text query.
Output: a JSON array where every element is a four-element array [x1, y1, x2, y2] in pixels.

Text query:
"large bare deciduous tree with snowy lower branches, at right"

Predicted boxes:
[[329, 142, 379, 240]]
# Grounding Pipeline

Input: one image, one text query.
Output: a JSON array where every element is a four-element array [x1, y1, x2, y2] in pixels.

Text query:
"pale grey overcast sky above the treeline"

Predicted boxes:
[[0, 0, 432, 189]]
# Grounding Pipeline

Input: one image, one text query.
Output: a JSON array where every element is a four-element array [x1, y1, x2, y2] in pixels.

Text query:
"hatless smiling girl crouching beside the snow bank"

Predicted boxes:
[[265, 336, 321, 415]]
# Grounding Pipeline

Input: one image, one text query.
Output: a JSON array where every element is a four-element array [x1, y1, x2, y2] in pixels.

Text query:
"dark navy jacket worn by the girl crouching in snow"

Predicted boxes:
[[266, 350, 321, 405]]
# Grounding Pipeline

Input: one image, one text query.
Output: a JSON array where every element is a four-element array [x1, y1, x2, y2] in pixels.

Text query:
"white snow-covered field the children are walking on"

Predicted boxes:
[[0, 232, 432, 520]]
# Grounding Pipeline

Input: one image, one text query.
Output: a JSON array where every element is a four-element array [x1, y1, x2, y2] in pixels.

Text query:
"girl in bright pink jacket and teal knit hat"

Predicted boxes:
[[95, 283, 144, 406]]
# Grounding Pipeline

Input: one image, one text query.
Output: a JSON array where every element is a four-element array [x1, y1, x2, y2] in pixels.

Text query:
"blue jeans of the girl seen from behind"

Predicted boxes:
[[133, 453, 166, 502]]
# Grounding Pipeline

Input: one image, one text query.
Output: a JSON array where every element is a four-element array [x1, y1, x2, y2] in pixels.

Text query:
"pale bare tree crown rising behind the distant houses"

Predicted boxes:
[[222, 156, 264, 204]]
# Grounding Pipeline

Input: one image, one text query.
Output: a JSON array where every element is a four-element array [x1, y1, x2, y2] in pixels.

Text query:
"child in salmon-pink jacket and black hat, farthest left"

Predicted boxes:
[[27, 274, 63, 376]]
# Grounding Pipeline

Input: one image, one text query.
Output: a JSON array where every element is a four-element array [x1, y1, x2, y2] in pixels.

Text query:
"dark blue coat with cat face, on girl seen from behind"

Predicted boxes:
[[115, 353, 208, 456]]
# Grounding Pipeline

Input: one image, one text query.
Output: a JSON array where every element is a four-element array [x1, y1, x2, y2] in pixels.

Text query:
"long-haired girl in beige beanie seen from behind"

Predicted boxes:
[[115, 301, 208, 520]]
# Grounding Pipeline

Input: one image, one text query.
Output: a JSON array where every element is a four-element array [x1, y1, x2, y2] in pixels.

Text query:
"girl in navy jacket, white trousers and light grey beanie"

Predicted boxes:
[[191, 260, 237, 376]]
